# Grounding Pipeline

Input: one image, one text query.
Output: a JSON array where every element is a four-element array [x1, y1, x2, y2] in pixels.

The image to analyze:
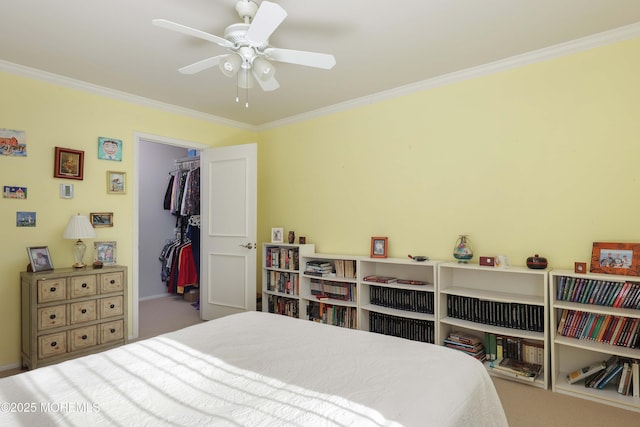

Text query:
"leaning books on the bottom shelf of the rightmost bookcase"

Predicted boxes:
[[567, 355, 640, 398]]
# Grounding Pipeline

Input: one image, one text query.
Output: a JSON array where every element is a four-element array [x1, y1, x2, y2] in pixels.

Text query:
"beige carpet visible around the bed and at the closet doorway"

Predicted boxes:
[[0, 296, 640, 427]]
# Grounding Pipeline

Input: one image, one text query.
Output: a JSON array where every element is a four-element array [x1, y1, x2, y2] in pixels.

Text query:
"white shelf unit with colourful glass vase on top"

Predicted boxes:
[[436, 262, 550, 389]]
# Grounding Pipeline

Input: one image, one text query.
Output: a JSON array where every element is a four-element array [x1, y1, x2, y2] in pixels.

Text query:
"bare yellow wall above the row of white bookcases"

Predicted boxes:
[[259, 39, 640, 269]]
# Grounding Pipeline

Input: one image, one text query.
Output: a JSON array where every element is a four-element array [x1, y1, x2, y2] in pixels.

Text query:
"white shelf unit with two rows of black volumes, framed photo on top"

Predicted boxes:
[[358, 258, 437, 343]]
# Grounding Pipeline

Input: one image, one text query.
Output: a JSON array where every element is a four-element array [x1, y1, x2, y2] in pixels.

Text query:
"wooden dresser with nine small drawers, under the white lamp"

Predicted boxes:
[[20, 266, 128, 369]]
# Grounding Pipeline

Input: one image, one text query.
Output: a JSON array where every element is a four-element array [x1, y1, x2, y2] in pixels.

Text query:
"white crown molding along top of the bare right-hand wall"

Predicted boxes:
[[258, 22, 640, 131]]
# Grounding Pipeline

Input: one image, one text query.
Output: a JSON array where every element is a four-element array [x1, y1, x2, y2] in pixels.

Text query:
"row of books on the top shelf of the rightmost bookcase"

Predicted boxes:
[[556, 276, 640, 309]]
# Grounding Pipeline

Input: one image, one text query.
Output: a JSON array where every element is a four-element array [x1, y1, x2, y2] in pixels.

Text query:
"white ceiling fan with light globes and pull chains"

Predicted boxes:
[[152, 0, 336, 106]]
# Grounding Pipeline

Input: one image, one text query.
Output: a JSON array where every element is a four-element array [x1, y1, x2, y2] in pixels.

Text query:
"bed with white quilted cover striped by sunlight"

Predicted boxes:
[[0, 312, 507, 426]]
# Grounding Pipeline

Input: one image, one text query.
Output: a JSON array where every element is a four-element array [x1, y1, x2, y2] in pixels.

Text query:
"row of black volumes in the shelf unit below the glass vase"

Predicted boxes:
[[447, 295, 545, 332]]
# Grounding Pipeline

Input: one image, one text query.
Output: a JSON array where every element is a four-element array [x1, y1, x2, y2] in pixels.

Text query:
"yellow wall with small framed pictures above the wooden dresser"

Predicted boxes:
[[0, 73, 257, 368]]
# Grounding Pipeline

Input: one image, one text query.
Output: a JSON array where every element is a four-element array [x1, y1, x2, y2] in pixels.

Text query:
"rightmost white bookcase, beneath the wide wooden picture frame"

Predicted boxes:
[[549, 270, 640, 411]]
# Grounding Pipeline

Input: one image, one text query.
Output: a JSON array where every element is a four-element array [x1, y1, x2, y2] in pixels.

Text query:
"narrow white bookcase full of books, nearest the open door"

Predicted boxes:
[[262, 243, 315, 317]]
